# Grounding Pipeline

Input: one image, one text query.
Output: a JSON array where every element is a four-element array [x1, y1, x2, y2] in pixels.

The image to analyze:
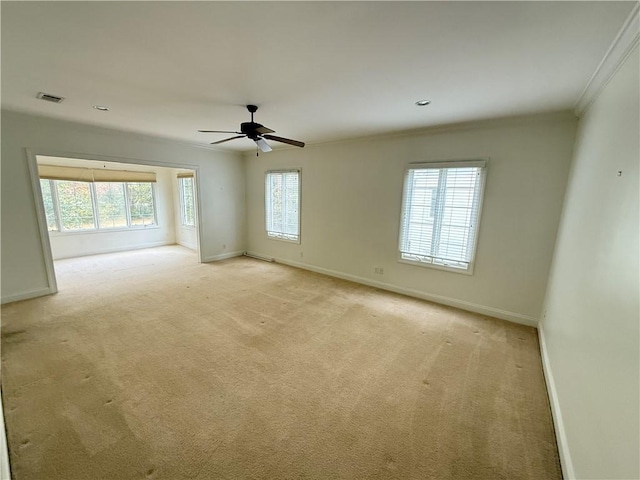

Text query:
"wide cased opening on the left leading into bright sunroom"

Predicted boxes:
[[31, 154, 201, 293]]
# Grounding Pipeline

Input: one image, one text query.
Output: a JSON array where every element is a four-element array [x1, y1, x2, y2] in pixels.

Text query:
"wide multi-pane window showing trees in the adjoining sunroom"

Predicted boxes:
[[40, 178, 156, 232]]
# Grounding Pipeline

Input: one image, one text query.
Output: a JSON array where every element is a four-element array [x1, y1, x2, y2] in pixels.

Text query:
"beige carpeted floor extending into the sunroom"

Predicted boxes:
[[2, 246, 561, 480]]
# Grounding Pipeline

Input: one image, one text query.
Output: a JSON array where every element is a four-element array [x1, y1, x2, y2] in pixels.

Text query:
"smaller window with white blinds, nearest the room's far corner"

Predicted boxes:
[[265, 170, 300, 243]]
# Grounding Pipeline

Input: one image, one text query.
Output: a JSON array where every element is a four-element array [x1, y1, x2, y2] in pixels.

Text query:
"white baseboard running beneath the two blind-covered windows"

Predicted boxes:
[[247, 252, 538, 327]]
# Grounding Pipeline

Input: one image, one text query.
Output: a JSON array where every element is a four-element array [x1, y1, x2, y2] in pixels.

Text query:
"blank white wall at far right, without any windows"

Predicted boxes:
[[541, 47, 640, 479]]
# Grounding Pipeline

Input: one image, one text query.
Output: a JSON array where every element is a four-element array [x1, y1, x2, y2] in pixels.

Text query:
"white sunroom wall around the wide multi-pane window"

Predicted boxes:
[[39, 157, 176, 260]]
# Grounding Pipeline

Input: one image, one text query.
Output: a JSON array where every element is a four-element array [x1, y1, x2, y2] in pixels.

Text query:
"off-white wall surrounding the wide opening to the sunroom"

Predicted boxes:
[[1, 111, 246, 302]]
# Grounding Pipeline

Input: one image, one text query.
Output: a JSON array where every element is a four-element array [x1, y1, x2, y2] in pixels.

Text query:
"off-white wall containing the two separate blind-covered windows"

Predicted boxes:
[[245, 114, 576, 325]]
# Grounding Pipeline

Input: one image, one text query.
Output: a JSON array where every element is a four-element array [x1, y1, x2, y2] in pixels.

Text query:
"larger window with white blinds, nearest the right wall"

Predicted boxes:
[[399, 160, 486, 273]]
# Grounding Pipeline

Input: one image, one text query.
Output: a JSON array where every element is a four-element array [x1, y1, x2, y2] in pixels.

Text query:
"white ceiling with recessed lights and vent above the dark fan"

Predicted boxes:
[[1, 1, 634, 150]]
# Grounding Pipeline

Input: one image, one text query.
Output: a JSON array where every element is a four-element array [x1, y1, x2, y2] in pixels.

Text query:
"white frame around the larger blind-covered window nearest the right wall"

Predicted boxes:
[[397, 158, 489, 275]]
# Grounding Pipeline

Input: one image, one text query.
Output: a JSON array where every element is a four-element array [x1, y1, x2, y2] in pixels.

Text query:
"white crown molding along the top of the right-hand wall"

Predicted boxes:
[[573, 2, 640, 117]]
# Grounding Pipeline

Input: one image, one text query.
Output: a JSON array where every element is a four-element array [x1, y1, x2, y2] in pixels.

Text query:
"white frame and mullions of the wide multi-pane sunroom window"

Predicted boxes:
[[38, 178, 160, 236]]
